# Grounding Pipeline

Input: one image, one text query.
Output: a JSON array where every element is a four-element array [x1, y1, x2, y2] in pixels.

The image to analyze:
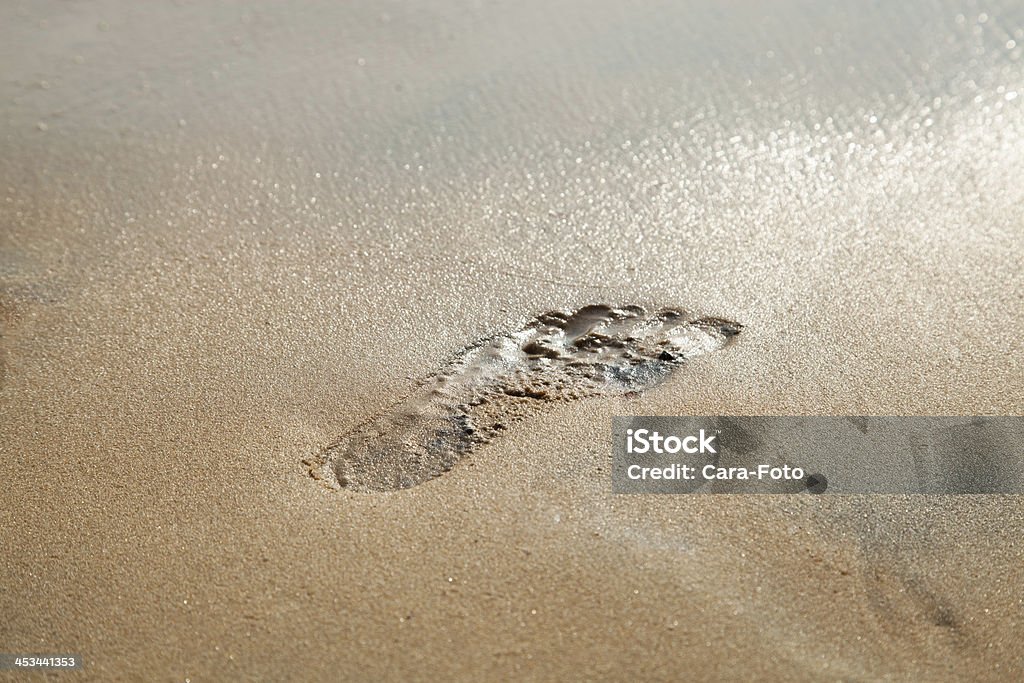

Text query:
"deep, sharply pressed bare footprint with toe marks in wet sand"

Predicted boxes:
[[306, 305, 741, 492]]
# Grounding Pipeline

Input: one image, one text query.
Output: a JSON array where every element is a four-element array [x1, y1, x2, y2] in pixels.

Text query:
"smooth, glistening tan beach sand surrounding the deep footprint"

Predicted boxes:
[[0, 1, 1024, 681]]
